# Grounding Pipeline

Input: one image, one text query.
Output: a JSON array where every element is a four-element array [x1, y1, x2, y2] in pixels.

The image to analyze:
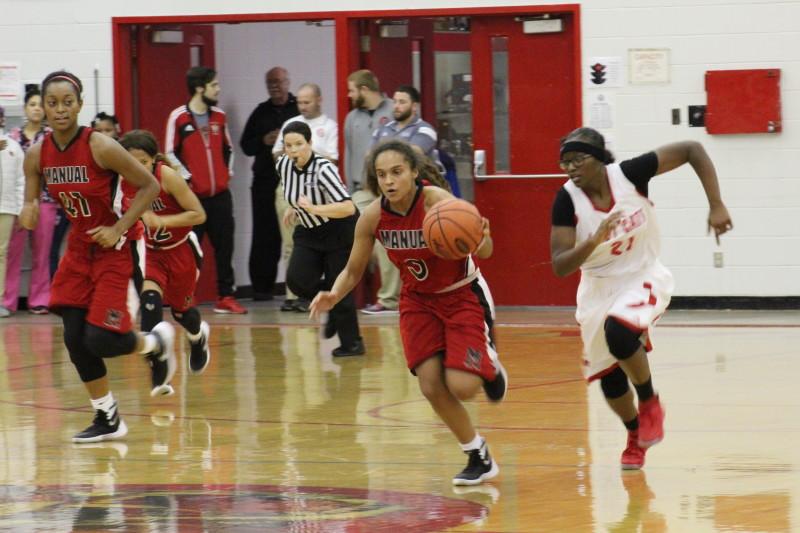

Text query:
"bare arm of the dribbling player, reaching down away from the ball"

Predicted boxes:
[[309, 199, 381, 318]]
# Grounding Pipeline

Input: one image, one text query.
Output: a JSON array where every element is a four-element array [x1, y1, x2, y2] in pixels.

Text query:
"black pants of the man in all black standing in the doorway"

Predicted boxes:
[[249, 178, 281, 295]]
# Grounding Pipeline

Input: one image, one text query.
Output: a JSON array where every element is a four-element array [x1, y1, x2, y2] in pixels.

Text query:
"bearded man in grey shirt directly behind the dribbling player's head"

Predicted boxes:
[[373, 85, 439, 163]]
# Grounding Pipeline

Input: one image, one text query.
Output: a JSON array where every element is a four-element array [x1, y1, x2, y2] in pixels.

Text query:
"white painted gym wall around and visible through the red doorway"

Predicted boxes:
[[0, 0, 800, 296]]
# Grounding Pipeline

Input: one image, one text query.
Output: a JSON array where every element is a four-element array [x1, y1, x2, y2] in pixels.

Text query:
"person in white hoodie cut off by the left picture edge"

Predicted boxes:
[[0, 107, 25, 318]]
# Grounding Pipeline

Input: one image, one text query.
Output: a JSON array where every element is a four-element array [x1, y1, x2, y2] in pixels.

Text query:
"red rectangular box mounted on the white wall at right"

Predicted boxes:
[[705, 68, 781, 133]]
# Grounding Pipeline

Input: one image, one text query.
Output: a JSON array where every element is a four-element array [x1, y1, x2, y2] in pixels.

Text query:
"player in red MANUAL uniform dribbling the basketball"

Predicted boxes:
[[311, 140, 508, 485]]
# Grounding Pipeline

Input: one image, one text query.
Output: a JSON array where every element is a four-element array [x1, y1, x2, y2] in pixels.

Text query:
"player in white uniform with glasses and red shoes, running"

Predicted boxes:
[[550, 128, 733, 470]]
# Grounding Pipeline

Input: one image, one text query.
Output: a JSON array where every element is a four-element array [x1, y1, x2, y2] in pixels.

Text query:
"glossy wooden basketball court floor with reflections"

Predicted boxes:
[[0, 305, 800, 532]]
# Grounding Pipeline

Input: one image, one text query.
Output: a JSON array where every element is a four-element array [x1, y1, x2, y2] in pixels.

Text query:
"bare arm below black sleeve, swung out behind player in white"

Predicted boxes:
[[655, 141, 733, 244]]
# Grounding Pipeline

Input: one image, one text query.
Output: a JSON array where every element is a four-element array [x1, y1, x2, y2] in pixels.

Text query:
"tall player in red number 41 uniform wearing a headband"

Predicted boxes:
[[19, 71, 176, 443]]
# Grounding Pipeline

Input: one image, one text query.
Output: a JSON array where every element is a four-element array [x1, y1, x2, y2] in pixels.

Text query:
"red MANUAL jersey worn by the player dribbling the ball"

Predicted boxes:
[[375, 186, 477, 293]]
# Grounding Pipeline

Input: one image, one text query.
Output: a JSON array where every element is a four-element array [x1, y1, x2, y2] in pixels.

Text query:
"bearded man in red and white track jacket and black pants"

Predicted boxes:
[[165, 67, 247, 314]]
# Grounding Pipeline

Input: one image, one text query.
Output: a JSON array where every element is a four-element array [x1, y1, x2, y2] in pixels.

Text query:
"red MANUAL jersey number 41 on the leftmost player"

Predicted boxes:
[[39, 126, 122, 243]]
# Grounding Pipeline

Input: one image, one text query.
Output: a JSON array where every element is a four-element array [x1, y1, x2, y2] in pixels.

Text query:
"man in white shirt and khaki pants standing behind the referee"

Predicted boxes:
[[272, 83, 339, 313]]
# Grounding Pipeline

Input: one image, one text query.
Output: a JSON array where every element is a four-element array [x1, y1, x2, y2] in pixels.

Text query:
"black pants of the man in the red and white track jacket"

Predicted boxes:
[[194, 190, 234, 298]]
